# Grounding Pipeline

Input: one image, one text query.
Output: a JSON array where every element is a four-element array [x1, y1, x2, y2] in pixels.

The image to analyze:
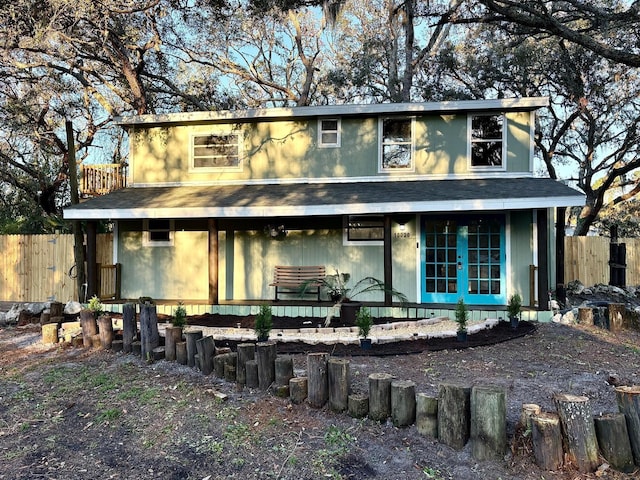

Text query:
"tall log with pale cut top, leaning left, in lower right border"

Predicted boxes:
[[554, 393, 598, 473]]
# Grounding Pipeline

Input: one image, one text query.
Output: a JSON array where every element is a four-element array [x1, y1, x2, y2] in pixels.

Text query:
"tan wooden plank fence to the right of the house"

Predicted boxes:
[[564, 237, 640, 285]]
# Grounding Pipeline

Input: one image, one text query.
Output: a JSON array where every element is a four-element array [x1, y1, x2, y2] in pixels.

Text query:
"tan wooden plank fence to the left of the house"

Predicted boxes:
[[0, 234, 115, 302]]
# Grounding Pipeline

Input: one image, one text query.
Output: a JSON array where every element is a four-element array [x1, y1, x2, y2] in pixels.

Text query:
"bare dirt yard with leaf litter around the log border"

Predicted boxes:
[[0, 312, 640, 480]]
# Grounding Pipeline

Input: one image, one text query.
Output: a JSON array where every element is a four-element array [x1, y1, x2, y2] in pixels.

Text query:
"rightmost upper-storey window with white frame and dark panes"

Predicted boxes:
[[467, 113, 507, 170]]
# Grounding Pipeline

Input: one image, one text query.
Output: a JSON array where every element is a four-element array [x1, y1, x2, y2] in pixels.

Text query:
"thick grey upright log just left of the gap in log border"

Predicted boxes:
[[471, 386, 507, 461]]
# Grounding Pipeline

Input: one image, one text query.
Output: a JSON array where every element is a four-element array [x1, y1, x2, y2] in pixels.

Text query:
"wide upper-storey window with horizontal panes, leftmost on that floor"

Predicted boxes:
[[190, 131, 242, 172]]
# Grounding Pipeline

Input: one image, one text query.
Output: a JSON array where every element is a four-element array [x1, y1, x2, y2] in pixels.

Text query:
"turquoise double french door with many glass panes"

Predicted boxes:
[[421, 215, 506, 305]]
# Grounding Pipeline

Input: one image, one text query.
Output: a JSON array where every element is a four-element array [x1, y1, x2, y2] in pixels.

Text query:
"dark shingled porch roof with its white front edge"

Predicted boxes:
[[64, 177, 584, 220]]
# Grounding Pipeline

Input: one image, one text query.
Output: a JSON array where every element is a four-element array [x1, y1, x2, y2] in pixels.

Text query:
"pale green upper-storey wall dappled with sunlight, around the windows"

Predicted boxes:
[[130, 112, 532, 185]]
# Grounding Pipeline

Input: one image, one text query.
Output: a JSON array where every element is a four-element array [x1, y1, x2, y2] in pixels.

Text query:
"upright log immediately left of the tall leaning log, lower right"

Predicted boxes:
[[531, 413, 564, 470]]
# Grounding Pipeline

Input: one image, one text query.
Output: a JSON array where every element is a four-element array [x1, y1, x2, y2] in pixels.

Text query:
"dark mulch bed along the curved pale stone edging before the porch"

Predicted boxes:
[[189, 316, 536, 357]]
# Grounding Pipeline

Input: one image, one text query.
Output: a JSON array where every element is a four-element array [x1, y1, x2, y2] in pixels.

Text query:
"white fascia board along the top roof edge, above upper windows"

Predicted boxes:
[[114, 97, 549, 126]]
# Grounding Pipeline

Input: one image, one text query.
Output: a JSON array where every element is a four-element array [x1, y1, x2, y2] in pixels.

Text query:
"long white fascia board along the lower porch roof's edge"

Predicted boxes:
[[64, 196, 584, 220]]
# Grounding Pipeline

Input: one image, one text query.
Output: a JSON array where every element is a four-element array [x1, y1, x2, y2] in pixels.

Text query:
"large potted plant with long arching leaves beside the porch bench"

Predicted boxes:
[[300, 269, 408, 327]]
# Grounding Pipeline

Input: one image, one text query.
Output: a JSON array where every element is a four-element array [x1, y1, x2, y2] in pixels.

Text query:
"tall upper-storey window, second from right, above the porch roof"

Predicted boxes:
[[378, 117, 414, 172]]
